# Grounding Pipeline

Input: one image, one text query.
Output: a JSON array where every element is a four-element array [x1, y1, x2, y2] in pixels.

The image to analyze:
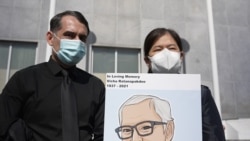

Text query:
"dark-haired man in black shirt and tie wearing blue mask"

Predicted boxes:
[[0, 11, 105, 141]]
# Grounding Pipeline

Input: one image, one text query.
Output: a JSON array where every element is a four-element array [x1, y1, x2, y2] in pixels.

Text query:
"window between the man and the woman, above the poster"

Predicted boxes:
[[92, 46, 140, 73]]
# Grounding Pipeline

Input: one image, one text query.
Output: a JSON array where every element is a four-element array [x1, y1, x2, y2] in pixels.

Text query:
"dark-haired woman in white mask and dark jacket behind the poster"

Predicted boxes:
[[144, 28, 225, 141]]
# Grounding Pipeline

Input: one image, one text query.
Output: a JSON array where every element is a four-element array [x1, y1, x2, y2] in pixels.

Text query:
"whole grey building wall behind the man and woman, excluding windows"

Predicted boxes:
[[0, 0, 250, 119]]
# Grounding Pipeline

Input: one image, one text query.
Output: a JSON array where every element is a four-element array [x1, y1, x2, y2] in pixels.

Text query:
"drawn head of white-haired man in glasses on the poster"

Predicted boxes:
[[115, 95, 174, 141]]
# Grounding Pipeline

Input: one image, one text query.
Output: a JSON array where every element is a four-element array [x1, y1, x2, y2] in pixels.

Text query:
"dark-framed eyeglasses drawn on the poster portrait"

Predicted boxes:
[[115, 121, 167, 139]]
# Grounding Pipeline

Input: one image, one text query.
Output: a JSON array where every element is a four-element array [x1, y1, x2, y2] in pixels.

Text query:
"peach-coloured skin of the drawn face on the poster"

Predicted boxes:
[[121, 100, 171, 141]]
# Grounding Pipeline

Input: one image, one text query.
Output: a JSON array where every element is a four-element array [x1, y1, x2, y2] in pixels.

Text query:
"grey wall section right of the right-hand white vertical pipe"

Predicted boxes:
[[213, 0, 250, 119]]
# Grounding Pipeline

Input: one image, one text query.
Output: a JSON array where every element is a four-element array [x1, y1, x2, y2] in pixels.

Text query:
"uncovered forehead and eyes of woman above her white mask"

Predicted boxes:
[[149, 33, 181, 57]]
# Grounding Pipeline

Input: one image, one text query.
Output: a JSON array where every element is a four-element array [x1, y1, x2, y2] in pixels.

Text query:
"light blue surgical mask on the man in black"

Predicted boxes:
[[53, 35, 87, 66]]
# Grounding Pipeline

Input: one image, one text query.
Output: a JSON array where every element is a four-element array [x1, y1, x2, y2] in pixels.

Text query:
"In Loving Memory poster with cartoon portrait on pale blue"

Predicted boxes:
[[104, 73, 202, 141]]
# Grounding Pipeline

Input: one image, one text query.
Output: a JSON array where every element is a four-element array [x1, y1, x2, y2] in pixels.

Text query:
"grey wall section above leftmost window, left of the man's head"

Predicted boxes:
[[0, 0, 49, 62]]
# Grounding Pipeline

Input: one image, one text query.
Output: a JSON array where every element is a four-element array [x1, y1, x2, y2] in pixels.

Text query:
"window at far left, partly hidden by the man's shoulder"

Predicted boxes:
[[0, 41, 37, 92]]
